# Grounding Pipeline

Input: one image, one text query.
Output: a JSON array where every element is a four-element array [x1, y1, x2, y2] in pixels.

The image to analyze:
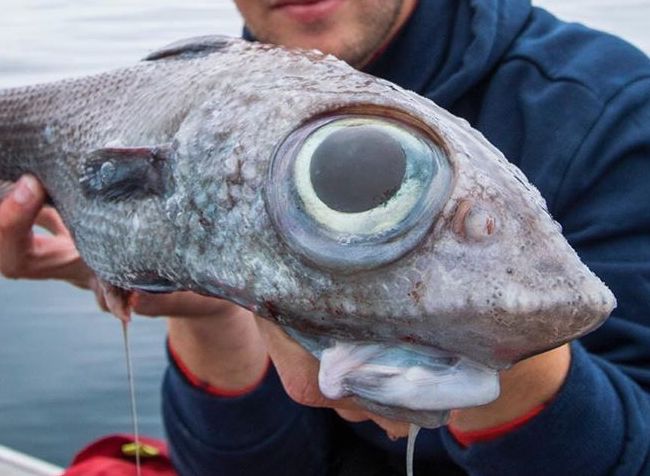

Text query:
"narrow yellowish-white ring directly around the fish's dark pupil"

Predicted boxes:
[[293, 117, 430, 235]]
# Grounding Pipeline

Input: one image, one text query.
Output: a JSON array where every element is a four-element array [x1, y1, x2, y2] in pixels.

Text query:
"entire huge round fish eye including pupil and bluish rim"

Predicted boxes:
[[267, 116, 451, 271]]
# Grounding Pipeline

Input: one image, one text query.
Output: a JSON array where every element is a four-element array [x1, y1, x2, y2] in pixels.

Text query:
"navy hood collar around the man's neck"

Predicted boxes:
[[243, 0, 532, 109]]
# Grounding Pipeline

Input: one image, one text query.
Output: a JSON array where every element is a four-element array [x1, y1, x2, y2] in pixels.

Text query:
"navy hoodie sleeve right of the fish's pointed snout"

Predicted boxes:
[[443, 76, 650, 476]]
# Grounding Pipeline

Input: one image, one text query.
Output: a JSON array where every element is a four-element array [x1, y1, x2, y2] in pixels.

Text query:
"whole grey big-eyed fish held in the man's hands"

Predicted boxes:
[[0, 37, 615, 427]]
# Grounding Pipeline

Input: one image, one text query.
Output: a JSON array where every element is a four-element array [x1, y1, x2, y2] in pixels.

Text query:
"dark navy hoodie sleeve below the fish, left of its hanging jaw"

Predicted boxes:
[[162, 354, 331, 476]]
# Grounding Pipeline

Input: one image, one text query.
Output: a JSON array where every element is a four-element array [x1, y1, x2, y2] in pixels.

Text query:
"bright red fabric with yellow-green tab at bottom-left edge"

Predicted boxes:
[[62, 435, 177, 476]]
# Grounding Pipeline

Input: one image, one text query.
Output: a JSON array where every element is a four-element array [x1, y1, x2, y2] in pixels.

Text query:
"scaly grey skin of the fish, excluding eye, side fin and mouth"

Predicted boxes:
[[0, 38, 615, 369]]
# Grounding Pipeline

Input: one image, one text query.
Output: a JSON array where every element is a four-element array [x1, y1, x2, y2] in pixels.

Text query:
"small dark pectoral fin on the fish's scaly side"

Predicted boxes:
[[80, 145, 172, 201]]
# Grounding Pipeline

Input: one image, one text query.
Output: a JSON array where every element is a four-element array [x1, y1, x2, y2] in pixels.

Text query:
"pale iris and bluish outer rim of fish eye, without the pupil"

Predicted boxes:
[[264, 115, 454, 274]]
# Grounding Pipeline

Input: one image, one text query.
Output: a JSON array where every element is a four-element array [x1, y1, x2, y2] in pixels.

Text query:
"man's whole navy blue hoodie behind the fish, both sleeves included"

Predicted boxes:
[[163, 0, 650, 476]]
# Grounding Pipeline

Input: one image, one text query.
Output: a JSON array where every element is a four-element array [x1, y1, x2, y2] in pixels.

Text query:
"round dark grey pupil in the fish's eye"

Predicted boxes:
[[309, 125, 406, 213]]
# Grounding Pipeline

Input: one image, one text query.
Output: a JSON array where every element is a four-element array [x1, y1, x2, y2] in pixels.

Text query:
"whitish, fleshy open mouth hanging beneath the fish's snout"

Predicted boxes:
[[284, 327, 499, 428]]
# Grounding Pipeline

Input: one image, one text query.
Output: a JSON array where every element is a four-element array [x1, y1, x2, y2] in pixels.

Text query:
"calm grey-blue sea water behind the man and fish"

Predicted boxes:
[[0, 0, 650, 465]]
